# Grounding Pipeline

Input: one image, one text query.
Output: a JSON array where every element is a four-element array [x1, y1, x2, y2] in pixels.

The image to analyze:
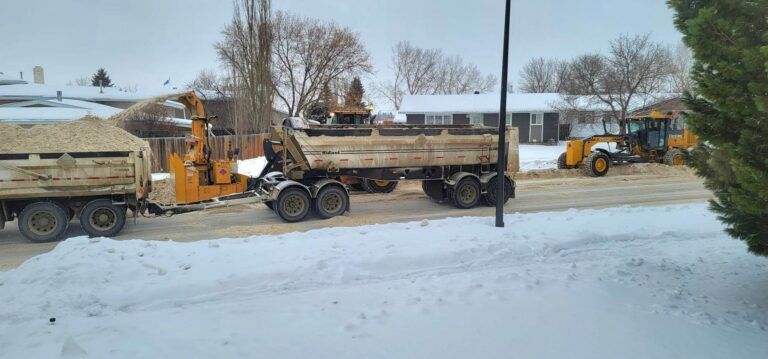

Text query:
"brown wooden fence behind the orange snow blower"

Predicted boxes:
[[145, 134, 266, 172]]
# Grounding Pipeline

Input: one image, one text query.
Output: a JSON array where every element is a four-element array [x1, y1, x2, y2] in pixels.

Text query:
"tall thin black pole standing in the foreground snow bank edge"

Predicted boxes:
[[496, 0, 511, 227]]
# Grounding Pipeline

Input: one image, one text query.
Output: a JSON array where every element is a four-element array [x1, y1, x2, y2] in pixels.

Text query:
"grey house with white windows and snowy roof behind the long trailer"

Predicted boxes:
[[399, 93, 576, 143]]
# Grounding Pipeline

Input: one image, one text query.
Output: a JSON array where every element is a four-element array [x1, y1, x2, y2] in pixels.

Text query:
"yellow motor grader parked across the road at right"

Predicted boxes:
[[557, 111, 698, 177]]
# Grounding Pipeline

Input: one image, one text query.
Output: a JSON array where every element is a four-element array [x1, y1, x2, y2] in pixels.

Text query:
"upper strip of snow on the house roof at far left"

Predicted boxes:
[[0, 84, 189, 102]]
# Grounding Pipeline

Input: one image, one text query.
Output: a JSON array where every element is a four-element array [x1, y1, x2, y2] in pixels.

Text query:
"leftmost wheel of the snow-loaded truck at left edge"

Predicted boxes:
[[19, 202, 69, 243]]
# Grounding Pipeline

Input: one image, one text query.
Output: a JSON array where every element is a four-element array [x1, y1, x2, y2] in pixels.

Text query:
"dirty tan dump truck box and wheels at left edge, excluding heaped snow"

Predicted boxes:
[[0, 146, 151, 242]]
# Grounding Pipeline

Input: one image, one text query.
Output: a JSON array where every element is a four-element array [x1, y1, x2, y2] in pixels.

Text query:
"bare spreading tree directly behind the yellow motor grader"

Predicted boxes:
[[565, 35, 670, 133]]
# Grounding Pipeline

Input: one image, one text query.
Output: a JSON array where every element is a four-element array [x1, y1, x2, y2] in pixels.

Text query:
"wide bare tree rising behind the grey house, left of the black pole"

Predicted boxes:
[[376, 41, 498, 109]]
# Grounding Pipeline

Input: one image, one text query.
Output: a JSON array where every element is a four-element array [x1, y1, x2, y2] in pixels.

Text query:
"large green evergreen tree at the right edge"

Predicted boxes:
[[668, 0, 768, 256]]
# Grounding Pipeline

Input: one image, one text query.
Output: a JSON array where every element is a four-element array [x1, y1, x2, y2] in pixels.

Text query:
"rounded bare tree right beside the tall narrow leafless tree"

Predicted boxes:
[[272, 11, 372, 116]]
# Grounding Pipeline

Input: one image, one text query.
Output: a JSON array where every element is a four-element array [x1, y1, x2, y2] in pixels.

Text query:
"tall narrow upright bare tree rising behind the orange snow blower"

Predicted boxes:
[[214, 0, 274, 132]]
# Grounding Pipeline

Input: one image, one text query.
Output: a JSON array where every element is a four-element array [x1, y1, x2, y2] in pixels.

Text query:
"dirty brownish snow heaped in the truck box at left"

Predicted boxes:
[[0, 117, 148, 153]]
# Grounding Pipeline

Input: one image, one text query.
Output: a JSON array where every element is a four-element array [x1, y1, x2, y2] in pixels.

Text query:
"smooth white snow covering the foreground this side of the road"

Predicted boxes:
[[0, 204, 768, 358]]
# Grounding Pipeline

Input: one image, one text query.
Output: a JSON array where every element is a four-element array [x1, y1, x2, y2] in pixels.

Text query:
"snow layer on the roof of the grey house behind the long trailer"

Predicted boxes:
[[400, 93, 572, 113]]
